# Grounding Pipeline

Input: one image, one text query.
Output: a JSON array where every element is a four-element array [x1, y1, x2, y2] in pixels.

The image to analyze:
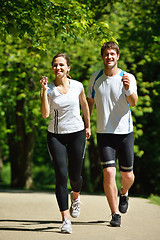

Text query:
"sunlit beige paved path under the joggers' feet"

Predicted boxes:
[[0, 192, 160, 240]]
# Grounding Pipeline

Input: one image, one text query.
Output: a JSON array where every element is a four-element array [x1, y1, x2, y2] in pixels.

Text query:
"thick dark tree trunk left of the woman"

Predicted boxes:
[[6, 76, 35, 189]]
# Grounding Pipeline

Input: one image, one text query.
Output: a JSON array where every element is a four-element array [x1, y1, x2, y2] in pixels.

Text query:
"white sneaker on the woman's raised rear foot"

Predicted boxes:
[[69, 192, 81, 218]]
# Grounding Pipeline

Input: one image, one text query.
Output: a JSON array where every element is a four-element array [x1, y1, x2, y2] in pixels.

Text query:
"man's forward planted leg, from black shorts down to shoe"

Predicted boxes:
[[97, 133, 121, 227]]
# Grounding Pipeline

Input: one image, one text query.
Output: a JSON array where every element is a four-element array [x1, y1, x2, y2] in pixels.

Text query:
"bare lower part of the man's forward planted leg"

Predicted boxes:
[[103, 167, 118, 214]]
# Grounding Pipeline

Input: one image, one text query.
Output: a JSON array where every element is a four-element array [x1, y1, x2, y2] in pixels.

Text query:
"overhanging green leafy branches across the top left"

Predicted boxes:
[[0, 0, 114, 49]]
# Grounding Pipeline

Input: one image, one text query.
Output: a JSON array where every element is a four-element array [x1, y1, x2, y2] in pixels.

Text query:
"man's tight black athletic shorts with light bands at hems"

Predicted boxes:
[[97, 132, 134, 172]]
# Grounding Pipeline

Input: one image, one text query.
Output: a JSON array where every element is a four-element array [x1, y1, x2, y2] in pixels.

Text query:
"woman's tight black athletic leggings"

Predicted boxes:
[[47, 130, 86, 211]]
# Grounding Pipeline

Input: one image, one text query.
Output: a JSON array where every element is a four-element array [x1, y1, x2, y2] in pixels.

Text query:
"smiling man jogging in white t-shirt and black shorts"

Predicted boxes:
[[87, 42, 138, 227]]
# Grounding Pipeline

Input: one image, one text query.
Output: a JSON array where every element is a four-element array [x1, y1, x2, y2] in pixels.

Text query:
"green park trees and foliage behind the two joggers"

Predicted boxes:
[[0, 0, 160, 201]]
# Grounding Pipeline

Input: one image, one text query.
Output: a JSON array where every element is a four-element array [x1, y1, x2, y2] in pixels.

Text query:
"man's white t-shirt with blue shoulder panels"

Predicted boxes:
[[87, 69, 137, 134]]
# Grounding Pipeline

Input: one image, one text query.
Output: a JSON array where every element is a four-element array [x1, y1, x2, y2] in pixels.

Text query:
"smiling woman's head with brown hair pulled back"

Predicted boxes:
[[52, 57, 70, 78]]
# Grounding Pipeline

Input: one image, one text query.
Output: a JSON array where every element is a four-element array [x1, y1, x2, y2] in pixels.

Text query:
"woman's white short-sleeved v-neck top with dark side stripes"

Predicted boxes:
[[47, 79, 84, 134]]
